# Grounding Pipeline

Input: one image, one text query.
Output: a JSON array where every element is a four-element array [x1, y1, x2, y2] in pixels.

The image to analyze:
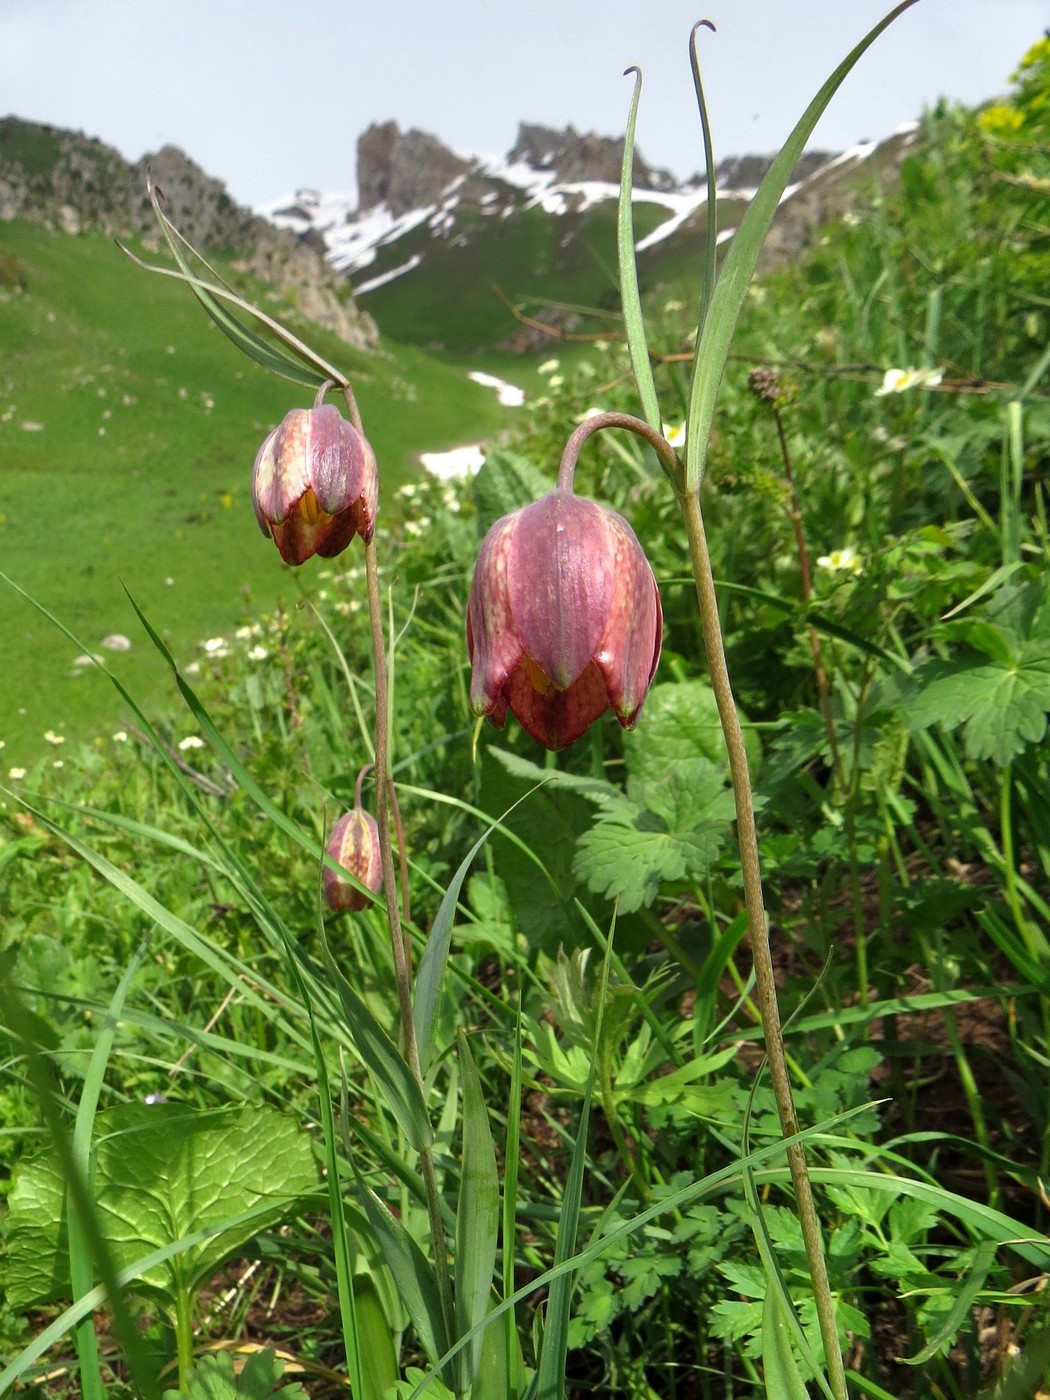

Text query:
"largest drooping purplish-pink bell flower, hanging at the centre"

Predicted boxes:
[[466, 486, 662, 749]]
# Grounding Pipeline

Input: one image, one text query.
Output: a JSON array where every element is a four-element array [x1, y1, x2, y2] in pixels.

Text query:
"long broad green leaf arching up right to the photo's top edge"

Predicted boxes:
[[686, 0, 916, 491]]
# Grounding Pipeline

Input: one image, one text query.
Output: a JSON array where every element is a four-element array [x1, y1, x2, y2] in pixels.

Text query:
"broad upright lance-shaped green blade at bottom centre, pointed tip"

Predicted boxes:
[[455, 1029, 500, 1387]]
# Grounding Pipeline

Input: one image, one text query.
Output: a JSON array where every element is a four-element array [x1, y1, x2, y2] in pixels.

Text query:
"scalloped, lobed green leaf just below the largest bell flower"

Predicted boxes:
[[574, 759, 734, 913]]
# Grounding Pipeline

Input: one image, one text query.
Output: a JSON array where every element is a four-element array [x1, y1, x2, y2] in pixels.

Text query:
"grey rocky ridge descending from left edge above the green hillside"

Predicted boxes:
[[0, 116, 378, 349]]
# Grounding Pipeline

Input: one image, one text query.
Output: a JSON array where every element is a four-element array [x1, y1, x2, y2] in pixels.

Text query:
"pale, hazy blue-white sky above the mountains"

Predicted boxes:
[[0, 0, 1050, 203]]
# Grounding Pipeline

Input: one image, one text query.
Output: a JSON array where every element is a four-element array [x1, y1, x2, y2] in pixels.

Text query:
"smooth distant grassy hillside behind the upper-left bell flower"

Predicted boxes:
[[0, 221, 508, 773]]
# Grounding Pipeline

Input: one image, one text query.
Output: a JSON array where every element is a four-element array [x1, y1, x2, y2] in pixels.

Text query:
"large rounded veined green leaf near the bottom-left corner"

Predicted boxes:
[[4, 1103, 318, 1308]]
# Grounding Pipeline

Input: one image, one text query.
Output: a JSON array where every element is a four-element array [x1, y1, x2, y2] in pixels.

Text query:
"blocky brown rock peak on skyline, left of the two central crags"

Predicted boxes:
[[357, 122, 470, 217]]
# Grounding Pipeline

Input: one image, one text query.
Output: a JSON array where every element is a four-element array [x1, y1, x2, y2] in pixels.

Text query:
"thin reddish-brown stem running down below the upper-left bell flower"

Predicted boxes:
[[364, 539, 455, 1337]]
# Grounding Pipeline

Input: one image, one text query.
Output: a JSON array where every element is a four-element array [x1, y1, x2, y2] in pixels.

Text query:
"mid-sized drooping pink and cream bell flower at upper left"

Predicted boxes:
[[252, 403, 379, 564]]
